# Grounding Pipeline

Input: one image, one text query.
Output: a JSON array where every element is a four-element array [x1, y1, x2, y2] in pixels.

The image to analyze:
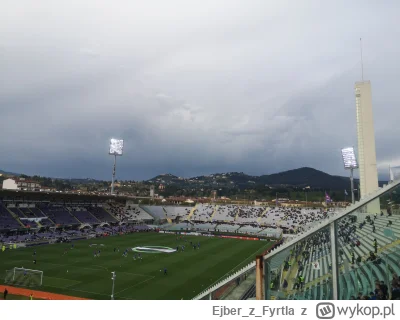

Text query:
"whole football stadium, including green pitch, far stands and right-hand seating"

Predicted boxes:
[[0, 176, 400, 300]]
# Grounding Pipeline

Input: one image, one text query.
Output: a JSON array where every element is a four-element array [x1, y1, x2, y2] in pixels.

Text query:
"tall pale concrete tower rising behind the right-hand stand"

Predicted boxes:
[[355, 81, 380, 213]]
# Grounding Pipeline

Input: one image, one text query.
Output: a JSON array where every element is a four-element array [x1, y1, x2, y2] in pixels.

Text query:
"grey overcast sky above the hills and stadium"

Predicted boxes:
[[0, 0, 400, 180]]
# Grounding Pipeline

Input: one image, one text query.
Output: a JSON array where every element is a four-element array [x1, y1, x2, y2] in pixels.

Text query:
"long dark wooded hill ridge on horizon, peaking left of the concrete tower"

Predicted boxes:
[[147, 167, 386, 190]]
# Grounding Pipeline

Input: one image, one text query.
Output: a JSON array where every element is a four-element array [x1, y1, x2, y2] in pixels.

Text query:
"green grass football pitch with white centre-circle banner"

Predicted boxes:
[[0, 233, 271, 300]]
